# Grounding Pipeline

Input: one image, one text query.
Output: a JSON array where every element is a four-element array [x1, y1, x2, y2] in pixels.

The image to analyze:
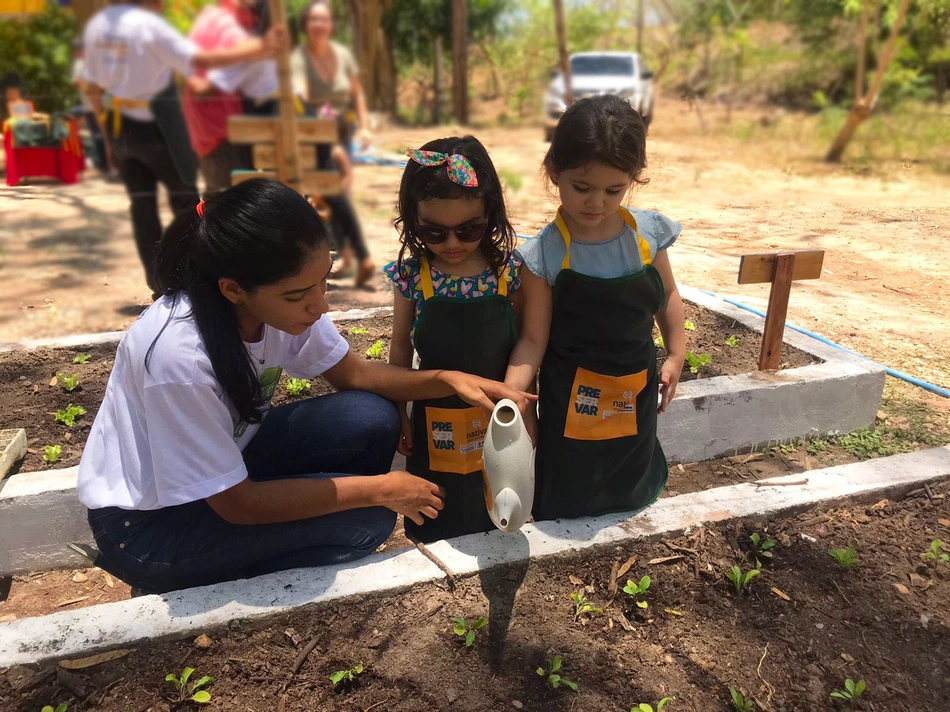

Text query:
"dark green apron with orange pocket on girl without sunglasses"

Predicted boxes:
[[533, 209, 667, 520]]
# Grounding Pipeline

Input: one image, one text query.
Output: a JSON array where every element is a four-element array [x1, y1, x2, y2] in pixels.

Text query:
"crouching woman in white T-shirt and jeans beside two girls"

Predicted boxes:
[[79, 180, 529, 592]]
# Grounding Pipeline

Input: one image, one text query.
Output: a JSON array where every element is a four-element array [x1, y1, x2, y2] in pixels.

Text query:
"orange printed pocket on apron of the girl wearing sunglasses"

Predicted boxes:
[[426, 407, 489, 475]]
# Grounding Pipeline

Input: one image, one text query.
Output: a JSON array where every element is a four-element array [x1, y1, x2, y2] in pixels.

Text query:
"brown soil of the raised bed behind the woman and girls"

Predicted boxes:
[[0, 302, 818, 472]]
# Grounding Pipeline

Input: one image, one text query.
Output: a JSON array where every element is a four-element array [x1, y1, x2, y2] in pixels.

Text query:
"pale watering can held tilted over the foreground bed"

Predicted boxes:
[[482, 398, 534, 532]]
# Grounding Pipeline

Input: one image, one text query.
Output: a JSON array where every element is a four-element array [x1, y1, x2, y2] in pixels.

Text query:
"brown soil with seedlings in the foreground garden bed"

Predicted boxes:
[[0, 483, 950, 712]]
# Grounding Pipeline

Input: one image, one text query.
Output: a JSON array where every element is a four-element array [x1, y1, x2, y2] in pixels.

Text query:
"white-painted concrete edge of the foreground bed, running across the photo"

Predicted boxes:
[[0, 446, 950, 667]]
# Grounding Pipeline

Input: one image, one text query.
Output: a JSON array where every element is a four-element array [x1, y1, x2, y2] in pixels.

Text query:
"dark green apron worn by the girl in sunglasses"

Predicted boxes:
[[405, 258, 518, 543]]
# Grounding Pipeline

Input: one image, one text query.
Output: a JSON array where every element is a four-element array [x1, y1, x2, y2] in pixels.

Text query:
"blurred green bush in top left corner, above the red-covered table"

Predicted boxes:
[[0, 2, 79, 113]]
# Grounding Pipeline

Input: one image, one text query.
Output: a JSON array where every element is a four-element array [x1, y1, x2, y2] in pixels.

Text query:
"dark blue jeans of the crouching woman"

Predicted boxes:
[[89, 391, 400, 593]]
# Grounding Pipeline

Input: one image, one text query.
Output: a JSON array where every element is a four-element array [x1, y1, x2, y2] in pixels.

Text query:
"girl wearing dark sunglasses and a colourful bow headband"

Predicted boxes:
[[385, 136, 521, 542]]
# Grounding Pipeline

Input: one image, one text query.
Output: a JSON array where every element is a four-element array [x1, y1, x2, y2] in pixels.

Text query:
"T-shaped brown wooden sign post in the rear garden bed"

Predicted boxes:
[[739, 250, 825, 371]]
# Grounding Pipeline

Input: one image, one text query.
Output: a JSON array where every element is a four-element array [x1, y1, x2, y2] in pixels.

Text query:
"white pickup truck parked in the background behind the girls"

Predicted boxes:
[[544, 52, 653, 141]]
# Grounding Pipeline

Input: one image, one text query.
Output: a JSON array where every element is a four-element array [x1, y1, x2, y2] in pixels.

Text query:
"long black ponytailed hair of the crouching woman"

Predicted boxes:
[[145, 179, 327, 423]]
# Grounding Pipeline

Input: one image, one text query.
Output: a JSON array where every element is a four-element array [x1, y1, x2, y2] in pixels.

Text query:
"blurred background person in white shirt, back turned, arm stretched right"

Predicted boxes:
[[82, 0, 286, 293]]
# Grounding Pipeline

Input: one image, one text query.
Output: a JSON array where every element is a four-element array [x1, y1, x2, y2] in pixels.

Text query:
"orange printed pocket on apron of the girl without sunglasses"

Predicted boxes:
[[564, 368, 647, 440]]
